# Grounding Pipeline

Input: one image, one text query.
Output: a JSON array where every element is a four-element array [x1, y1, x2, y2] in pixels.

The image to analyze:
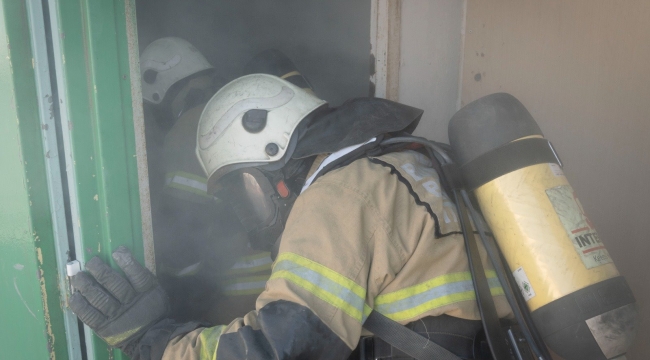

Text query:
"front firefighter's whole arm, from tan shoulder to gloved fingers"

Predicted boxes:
[[70, 162, 417, 360]]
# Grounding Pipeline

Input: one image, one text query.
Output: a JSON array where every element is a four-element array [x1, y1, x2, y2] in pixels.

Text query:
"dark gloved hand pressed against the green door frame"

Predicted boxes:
[[69, 246, 169, 357]]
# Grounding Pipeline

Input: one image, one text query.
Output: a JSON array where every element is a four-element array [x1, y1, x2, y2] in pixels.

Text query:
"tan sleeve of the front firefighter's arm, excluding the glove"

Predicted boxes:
[[163, 162, 413, 360]]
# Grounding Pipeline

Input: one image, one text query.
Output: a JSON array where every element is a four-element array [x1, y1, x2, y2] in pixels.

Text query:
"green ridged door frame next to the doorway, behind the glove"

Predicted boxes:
[[48, 0, 154, 360]]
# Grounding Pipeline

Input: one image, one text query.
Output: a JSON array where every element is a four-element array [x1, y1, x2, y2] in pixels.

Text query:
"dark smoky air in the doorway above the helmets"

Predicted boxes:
[[137, 0, 370, 106]]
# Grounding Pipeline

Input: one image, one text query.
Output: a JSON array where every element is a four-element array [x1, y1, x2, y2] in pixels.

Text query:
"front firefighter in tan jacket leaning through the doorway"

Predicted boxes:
[[70, 74, 511, 359]]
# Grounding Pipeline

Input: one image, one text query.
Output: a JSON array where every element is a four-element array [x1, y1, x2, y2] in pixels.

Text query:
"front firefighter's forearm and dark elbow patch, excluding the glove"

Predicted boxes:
[[163, 300, 351, 360]]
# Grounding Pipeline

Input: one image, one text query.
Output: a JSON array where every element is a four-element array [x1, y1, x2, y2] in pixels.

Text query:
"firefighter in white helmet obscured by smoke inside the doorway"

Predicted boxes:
[[140, 37, 239, 319]]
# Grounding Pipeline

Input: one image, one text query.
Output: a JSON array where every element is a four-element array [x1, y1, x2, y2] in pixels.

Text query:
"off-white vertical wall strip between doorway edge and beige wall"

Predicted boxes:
[[399, 0, 464, 142]]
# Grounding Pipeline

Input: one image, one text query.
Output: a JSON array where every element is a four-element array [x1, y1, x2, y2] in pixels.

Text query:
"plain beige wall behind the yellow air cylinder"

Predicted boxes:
[[461, 0, 650, 360]]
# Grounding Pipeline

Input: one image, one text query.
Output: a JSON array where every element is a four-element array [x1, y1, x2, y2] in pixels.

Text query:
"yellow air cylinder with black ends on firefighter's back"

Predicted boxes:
[[449, 93, 637, 360]]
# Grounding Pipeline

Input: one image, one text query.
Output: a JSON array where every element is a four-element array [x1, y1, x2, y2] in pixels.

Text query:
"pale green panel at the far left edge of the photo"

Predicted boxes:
[[0, 1, 69, 359]]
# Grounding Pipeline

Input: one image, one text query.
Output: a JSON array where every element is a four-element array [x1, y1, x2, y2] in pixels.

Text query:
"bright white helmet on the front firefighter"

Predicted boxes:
[[196, 74, 327, 186]]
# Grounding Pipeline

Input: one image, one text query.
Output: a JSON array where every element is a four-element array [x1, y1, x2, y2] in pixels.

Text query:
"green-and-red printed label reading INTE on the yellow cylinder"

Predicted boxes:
[[546, 185, 612, 269]]
